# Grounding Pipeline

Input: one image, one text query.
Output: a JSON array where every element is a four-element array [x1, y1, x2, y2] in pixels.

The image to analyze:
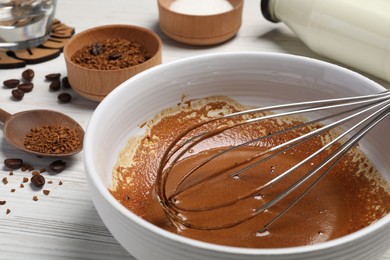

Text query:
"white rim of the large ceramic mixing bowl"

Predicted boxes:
[[84, 51, 390, 256]]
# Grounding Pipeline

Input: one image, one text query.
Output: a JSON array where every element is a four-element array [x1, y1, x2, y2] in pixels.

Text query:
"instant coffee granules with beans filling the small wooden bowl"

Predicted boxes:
[[71, 38, 150, 70]]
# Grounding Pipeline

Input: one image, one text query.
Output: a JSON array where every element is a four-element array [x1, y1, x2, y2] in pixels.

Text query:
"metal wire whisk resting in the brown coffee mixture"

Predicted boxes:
[[156, 91, 390, 232]]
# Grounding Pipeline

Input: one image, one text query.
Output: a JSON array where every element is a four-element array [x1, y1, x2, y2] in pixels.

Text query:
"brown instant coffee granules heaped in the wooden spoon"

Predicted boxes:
[[24, 125, 81, 154]]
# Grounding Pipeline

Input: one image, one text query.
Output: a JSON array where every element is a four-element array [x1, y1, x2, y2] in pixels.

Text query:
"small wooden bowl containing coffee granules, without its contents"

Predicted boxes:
[[64, 25, 162, 101]]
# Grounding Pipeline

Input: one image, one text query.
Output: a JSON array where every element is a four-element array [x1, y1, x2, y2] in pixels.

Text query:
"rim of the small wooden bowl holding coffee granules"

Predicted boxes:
[[63, 24, 162, 74]]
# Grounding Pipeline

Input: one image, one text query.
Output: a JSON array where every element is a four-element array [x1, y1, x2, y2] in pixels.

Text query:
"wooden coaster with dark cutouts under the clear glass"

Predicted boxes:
[[0, 19, 75, 69]]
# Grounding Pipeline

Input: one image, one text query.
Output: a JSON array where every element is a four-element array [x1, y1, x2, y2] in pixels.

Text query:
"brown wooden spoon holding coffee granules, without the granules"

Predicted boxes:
[[0, 109, 84, 157]]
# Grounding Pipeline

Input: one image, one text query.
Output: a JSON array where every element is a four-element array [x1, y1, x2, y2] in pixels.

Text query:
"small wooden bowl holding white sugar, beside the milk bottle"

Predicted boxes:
[[158, 0, 243, 45]]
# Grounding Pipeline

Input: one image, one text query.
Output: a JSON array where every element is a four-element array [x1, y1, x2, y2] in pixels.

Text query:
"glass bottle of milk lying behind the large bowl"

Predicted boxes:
[[261, 0, 390, 81]]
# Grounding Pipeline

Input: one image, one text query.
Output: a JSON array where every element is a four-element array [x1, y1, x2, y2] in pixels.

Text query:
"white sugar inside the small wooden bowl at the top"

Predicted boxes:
[[170, 0, 233, 15]]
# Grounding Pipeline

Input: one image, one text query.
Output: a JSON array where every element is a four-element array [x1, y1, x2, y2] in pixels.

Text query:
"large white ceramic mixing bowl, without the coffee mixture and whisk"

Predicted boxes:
[[84, 53, 390, 260]]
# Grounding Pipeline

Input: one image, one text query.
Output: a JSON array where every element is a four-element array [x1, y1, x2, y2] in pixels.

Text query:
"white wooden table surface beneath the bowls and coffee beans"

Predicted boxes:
[[0, 0, 390, 259]]
